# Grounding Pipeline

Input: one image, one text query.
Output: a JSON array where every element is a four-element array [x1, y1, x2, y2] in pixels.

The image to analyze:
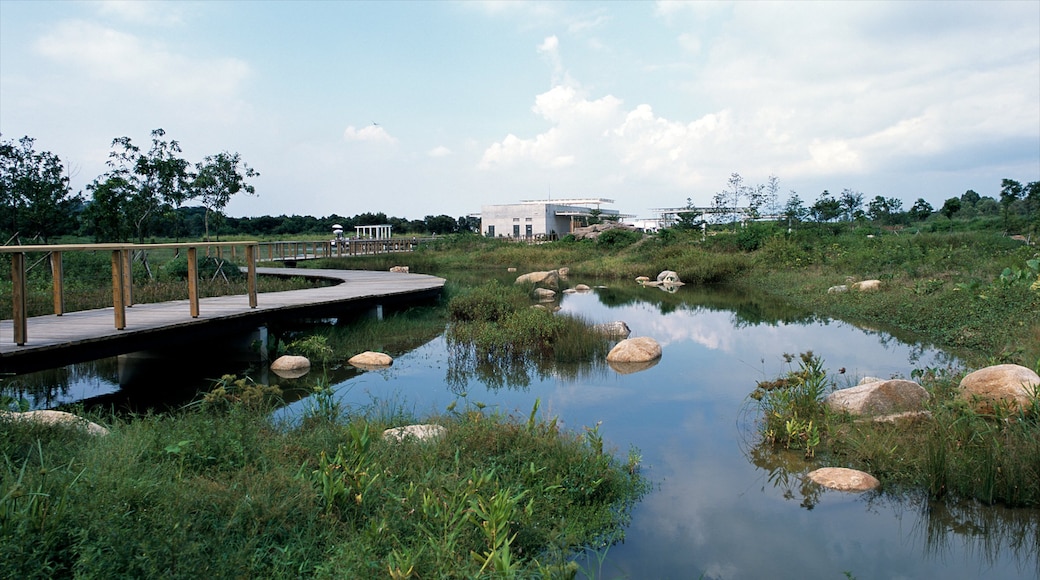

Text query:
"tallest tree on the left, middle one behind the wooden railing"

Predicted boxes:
[[108, 129, 192, 242]]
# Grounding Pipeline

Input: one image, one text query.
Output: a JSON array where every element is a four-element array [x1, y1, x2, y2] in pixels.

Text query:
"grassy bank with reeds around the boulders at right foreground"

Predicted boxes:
[[750, 352, 1040, 507]]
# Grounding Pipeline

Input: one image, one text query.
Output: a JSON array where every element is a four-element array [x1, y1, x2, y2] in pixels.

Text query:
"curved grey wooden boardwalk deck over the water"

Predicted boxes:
[[0, 268, 444, 372]]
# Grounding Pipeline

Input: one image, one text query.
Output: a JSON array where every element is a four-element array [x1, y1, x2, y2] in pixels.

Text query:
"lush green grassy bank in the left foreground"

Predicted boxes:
[[0, 388, 645, 578]]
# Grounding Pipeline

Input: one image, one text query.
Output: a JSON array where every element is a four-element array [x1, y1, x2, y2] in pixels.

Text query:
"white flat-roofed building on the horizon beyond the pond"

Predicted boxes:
[[480, 199, 620, 239]]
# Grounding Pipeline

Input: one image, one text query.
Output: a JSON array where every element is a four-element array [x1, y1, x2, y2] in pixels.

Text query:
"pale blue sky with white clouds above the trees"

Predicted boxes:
[[0, 0, 1040, 219]]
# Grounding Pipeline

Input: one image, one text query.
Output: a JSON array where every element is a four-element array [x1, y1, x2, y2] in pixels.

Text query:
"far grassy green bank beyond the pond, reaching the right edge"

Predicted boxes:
[[347, 225, 1040, 367]]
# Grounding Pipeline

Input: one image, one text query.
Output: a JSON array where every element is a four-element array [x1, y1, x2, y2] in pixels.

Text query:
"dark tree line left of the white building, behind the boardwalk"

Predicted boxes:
[[0, 129, 479, 244]]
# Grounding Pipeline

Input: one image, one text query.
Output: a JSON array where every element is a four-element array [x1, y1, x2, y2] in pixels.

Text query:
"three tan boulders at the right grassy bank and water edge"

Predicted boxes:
[[808, 365, 1040, 492]]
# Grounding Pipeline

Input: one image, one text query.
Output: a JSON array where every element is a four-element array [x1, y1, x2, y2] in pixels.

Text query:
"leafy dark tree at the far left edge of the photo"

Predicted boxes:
[[0, 136, 83, 243]]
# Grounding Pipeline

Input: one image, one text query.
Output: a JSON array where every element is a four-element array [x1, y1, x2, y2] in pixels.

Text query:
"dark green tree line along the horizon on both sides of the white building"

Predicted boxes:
[[0, 135, 1040, 244]]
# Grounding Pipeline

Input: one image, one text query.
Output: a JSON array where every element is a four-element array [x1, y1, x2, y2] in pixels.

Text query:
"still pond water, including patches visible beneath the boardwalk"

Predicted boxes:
[[10, 288, 1040, 579]]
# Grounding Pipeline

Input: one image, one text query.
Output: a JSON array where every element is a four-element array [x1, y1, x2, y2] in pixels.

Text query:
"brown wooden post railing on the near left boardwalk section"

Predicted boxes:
[[0, 241, 258, 346]]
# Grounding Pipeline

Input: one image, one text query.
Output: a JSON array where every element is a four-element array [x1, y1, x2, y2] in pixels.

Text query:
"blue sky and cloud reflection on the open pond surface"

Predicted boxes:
[[278, 291, 1036, 579]]
